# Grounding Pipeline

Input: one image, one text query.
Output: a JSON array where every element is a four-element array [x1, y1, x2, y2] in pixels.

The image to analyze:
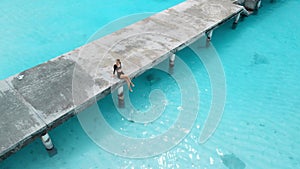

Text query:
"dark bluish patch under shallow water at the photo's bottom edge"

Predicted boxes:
[[220, 154, 246, 169]]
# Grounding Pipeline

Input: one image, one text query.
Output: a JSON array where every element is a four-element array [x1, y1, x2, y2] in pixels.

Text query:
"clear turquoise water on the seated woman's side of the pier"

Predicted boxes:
[[0, 0, 300, 169]]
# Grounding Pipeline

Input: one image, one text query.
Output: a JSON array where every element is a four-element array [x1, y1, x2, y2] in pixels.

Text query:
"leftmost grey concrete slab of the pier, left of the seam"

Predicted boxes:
[[0, 81, 46, 156]]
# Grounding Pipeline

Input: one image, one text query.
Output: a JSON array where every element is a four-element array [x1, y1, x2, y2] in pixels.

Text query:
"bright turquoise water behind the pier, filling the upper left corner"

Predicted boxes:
[[0, 0, 183, 79]]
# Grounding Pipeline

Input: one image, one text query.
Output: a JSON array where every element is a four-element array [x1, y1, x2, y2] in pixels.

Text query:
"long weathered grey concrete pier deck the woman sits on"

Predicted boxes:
[[0, 0, 243, 161]]
